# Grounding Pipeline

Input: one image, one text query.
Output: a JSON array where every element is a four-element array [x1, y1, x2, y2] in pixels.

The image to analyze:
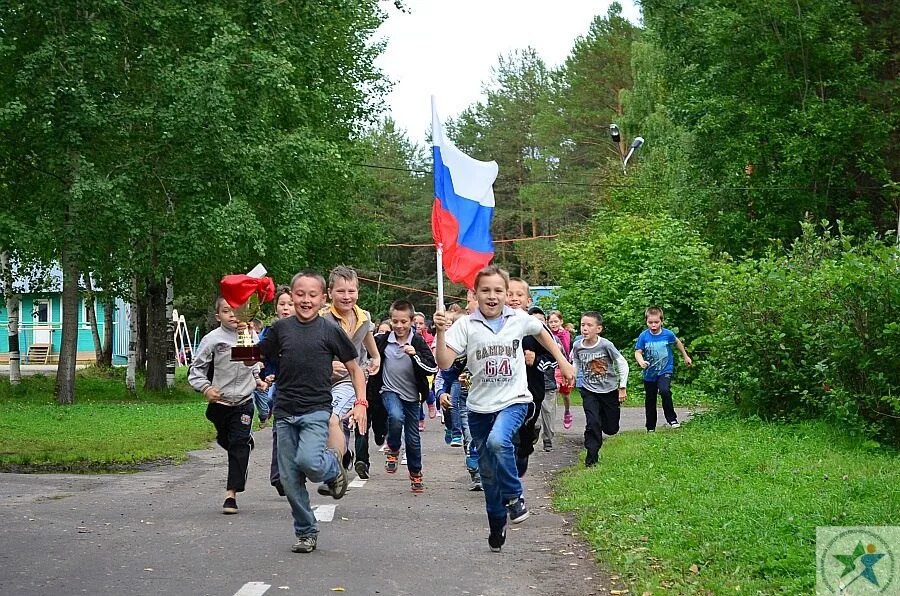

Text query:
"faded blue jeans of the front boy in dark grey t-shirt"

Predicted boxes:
[[275, 409, 341, 536]]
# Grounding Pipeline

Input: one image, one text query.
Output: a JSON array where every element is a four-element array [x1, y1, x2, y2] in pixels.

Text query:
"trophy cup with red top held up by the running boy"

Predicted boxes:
[[219, 264, 275, 364]]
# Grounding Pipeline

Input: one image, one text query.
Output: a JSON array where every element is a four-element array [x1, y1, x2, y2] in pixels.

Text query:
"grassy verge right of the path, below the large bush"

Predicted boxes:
[[554, 415, 900, 594]]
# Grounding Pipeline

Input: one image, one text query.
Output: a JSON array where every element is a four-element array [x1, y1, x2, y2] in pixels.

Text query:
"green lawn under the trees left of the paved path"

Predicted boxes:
[[0, 369, 215, 472]]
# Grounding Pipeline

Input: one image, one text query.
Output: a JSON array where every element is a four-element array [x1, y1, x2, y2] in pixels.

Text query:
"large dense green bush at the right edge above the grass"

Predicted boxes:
[[698, 224, 900, 442]]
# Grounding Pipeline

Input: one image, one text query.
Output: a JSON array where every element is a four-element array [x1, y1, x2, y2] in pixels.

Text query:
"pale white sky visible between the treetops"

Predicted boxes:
[[376, 0, 640, 144]]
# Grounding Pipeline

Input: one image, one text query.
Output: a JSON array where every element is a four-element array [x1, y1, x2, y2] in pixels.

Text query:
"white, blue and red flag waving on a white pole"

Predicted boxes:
[[431, 100, 499, 288]]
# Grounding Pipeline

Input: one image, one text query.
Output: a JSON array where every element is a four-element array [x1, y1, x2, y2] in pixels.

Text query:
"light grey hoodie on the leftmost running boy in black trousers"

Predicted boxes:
[[188, 326, 259, 406]]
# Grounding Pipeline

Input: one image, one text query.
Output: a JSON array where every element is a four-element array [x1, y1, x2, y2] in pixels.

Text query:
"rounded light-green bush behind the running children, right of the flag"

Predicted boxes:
[[556, 211, 713, 352]]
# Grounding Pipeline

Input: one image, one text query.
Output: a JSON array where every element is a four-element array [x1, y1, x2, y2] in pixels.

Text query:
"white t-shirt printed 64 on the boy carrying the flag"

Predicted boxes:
[[446, 307, 544, 414]]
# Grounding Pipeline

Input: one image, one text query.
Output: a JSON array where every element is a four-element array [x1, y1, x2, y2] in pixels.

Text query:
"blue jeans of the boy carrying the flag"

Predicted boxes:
[[469, 404, 528, 529]]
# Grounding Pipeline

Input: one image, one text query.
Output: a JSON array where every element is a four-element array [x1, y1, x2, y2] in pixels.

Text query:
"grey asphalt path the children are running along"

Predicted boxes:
[[0, 400, 686, 596]]
